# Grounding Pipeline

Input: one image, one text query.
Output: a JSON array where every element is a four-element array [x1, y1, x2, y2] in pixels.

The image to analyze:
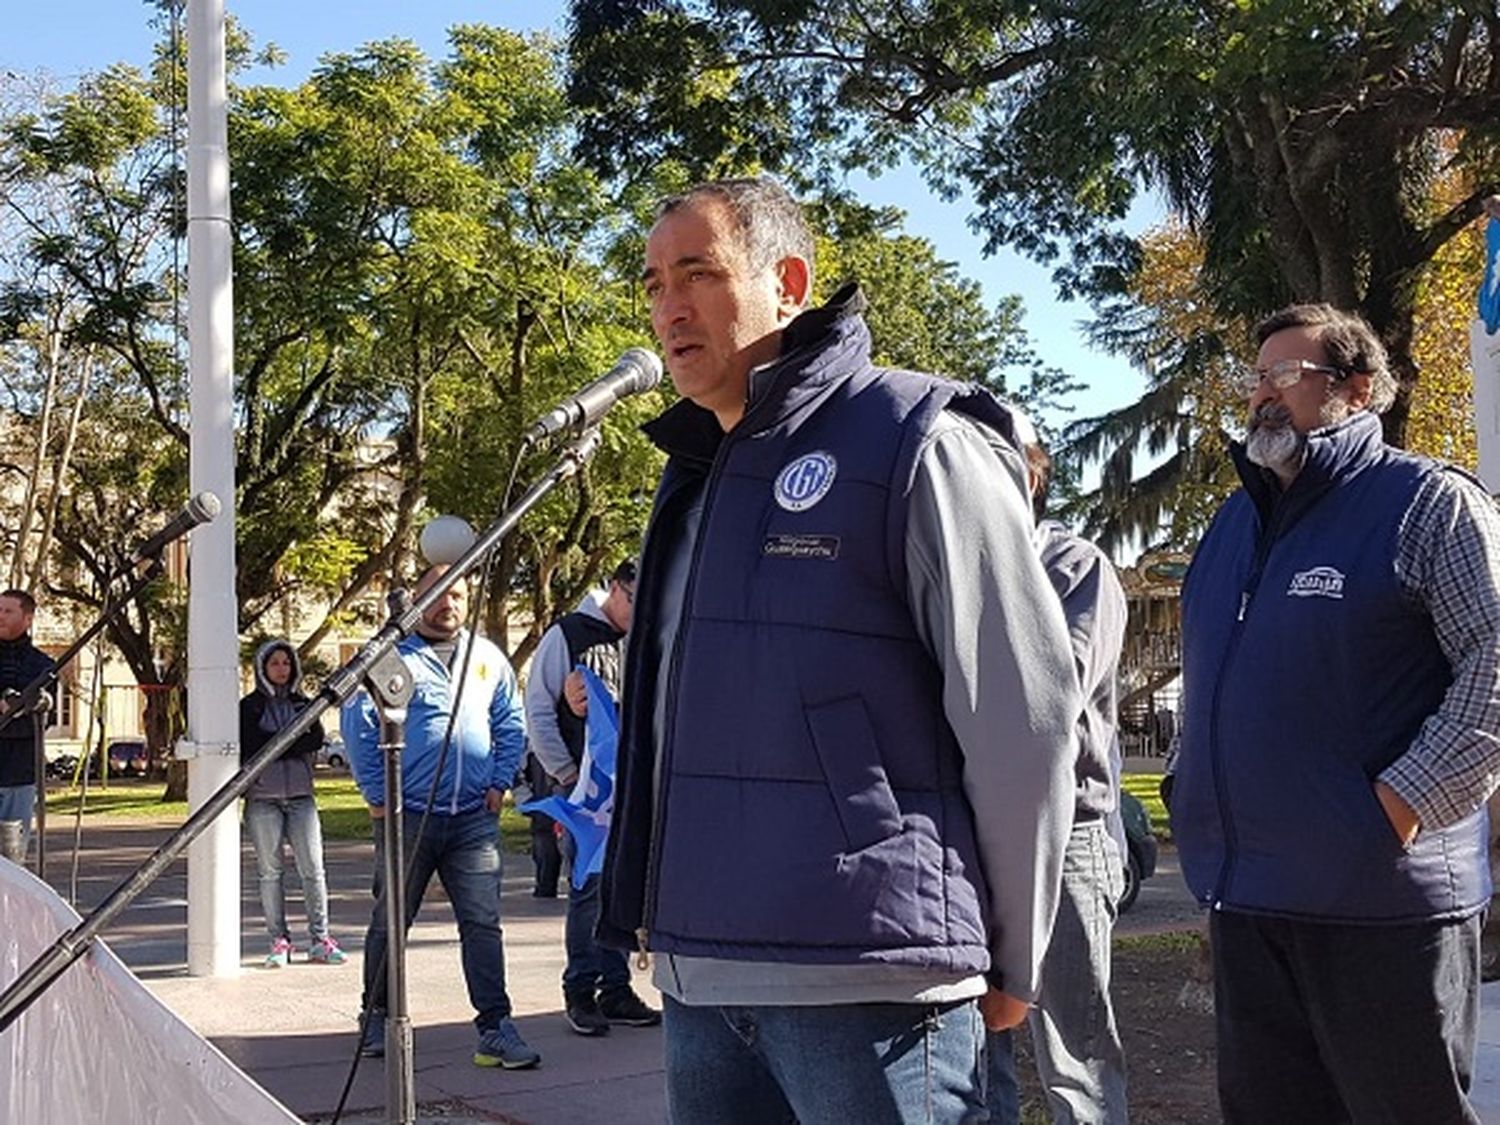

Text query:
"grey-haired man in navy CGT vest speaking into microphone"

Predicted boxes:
[[600, 179, 1082, 1125]]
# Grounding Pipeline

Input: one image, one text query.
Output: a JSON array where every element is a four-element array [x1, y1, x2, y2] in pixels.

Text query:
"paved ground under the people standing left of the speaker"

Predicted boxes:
[[48, 822, 666, 1125]]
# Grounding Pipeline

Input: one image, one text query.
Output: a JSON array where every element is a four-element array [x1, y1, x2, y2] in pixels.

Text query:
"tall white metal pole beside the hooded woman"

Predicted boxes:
[[180, 0, 240, 977]]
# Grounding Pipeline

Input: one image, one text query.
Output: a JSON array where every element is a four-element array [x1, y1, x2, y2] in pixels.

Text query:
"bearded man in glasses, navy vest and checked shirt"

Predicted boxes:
[[1172, 305, 1500, 1125]]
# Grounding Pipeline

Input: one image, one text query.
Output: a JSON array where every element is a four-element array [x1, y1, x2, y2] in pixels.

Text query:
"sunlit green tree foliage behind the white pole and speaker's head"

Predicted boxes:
[[0, 13, 1068, 683]]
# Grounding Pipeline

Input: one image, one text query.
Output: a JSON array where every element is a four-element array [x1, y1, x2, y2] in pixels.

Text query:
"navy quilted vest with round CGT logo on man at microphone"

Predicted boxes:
[[600, 291, 1010, 972]]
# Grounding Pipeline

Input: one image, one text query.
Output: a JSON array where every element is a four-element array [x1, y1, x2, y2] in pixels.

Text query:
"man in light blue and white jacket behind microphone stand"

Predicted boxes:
[[341, 566, 542, 1070]]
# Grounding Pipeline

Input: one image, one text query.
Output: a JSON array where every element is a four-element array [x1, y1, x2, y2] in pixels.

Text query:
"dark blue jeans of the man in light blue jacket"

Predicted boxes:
[[363, 809, 510, 1032]]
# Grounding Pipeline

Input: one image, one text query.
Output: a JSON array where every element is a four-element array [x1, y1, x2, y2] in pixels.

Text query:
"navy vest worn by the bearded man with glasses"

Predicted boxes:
[[1172, 413, 1490, 924]]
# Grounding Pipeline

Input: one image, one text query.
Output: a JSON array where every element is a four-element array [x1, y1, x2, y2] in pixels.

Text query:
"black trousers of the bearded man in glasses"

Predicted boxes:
[[1211, 912, 1482, 1125]]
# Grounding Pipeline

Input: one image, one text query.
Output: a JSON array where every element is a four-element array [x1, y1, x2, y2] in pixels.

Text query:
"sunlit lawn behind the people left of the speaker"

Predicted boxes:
[[47, 773, 531, 852]]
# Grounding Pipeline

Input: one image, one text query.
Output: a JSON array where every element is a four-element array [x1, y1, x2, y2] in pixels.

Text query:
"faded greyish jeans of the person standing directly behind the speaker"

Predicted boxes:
[[990, 821, 1130, 1125]]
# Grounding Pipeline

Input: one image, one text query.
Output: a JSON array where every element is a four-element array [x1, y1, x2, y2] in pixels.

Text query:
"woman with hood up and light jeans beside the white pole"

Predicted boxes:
[[240, 641, 344, 969]]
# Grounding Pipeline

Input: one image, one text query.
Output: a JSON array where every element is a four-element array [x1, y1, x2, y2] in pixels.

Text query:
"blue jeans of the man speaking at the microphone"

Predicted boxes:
[[665, 996, 987, 1125]]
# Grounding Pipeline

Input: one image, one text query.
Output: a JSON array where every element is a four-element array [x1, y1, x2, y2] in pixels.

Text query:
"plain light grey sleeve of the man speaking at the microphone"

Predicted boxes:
[[906, 414, 1083, 1001]]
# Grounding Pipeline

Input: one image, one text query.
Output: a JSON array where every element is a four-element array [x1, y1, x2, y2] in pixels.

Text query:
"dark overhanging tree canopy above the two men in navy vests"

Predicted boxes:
[[570, 0, 1500, 443]]
